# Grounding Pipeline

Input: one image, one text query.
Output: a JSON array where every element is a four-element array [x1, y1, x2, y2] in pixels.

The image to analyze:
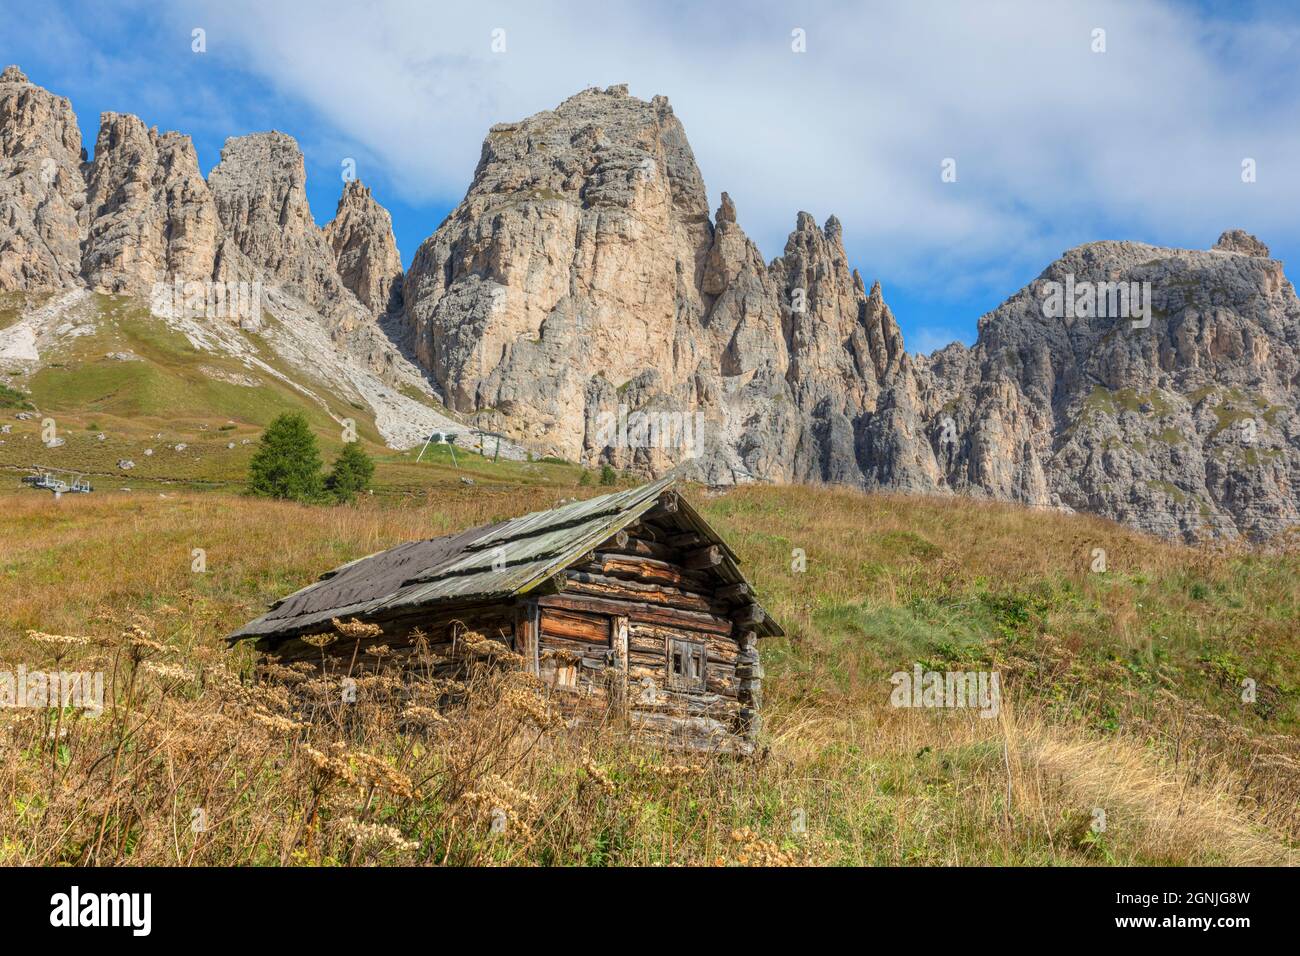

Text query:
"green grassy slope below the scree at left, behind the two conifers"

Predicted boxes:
[[0, 294, 576, 494]]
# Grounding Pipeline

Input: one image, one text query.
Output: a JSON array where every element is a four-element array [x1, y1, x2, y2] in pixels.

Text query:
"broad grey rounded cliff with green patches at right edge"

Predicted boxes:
[[931, 232, 1300, 540]]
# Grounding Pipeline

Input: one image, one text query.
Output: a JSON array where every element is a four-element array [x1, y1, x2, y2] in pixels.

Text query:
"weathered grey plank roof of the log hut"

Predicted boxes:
[[229, 475, 781, 641]]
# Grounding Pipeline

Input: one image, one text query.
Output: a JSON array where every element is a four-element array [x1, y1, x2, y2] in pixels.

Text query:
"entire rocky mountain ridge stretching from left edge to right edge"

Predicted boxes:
[[0, 68, 1300, 541]]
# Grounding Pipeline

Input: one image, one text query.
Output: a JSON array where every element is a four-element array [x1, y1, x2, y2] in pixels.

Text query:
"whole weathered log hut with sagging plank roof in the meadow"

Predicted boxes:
[[230, 476, 783, 753]]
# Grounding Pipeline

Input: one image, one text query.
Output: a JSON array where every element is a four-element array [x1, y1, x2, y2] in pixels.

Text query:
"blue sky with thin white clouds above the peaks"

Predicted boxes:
[[0, 0, 1300, 351]]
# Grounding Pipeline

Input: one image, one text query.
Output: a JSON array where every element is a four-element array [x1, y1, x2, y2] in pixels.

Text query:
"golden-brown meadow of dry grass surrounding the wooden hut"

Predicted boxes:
[[0, 478, 1300, 865]]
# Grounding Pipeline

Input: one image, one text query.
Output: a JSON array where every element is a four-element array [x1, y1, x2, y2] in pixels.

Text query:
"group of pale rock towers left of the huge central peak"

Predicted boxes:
[[0, 66, 430, 390]]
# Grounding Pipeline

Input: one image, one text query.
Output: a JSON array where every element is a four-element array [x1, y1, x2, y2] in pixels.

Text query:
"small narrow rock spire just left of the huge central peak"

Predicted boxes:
[[325, 179, 402, 315]]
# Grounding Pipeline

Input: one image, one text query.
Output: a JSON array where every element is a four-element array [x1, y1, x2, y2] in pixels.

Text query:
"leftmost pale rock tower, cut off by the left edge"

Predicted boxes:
[[0, 66, 86, 291]]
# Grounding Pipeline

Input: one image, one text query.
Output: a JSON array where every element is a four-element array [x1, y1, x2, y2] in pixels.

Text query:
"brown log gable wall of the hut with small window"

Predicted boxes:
[[525, 519, 762, 752]]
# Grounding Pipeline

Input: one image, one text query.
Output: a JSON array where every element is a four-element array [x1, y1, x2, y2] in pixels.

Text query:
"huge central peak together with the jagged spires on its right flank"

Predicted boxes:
[[404, 81, 920, 480]]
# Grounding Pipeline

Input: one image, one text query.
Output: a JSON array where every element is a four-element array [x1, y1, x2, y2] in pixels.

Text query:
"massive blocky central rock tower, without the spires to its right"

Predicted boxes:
[[403, 88, 712, 458]]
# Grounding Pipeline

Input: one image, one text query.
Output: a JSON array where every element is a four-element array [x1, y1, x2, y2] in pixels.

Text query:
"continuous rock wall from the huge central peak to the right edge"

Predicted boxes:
[[404, 87, 1300, 540]]
